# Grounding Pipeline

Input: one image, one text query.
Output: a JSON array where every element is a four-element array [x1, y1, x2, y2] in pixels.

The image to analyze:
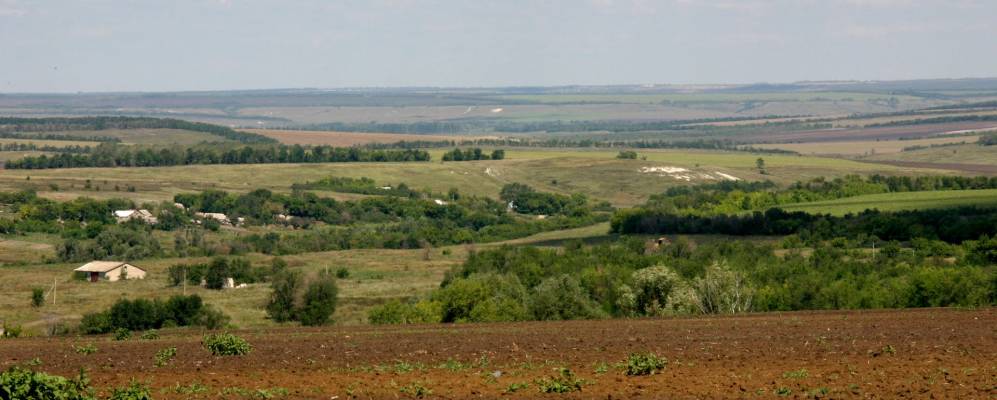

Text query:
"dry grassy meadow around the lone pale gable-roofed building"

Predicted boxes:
[[0, 223, 628, 330]]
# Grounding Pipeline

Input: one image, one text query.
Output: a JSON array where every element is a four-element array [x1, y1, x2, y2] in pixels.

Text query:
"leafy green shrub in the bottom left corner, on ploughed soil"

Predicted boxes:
[[0, 366, 96, 400]]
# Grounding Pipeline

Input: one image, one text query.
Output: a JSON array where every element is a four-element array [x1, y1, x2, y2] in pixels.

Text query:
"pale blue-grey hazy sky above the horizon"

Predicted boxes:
[[0, 0, 997, 93]]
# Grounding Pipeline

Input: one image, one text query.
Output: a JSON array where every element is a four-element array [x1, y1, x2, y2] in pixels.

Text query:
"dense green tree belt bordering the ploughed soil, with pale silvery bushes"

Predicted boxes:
[[368, 237, 997, 324]]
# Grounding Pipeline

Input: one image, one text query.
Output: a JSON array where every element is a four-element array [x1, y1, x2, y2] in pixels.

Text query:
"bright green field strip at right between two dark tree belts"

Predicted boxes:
[[779, 189, 997, 215]]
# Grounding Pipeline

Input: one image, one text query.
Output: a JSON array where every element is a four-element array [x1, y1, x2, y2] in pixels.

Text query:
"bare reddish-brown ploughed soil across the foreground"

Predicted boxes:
[[0, 309, 997, 399]]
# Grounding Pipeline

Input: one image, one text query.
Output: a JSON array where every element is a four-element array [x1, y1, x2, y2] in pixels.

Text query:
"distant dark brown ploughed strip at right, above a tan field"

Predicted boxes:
[[746, 121, 997, 143]]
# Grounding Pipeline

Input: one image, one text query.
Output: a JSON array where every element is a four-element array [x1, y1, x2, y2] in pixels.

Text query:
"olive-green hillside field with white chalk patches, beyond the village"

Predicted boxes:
[[0, 148, 924, 206]]
